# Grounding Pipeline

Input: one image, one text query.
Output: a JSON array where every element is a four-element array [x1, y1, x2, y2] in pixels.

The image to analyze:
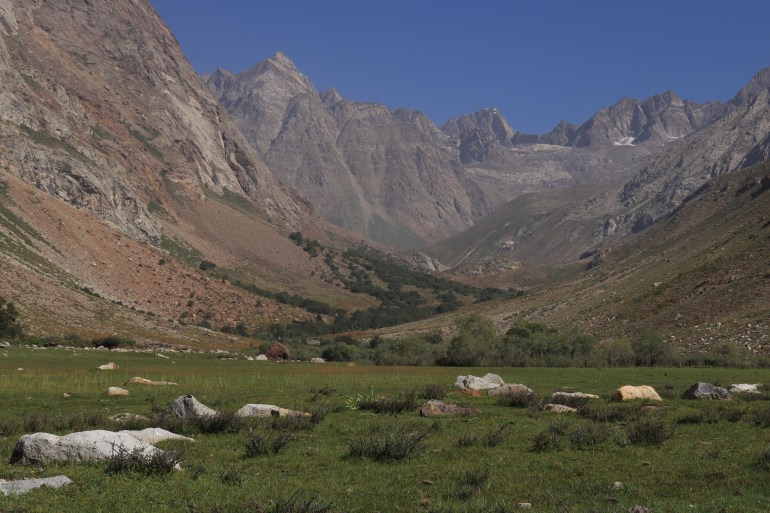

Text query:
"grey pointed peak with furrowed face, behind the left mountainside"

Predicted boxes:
[[205, 53, 491, 248]]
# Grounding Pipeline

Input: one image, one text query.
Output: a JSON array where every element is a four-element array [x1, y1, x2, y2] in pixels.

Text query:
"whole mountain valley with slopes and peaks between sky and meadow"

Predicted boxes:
[[0, 0, 770, 355]]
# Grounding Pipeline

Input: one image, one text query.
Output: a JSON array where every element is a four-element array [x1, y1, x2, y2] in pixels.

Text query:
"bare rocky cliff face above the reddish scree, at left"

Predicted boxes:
[[0, 0, 302, 244]]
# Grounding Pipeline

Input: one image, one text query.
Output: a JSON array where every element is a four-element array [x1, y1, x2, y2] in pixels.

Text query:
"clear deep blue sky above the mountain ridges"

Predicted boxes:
[[151, 0, 770, 133]]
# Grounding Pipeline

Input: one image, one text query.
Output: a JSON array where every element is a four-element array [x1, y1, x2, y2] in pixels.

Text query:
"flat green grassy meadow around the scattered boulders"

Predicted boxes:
[[0, 348, 770, 513]]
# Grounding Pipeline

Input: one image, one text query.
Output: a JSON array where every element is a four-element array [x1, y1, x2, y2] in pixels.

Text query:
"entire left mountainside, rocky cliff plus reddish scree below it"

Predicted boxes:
[[0, 0, 372, 341]]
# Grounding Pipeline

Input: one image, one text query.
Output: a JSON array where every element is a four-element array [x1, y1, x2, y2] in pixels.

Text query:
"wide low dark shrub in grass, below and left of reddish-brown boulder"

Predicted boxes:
[[348, 428, 428, 461]]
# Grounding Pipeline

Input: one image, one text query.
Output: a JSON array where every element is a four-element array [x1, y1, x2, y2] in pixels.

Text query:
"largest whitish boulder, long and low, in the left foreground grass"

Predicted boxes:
[[11, 429, 165, 465]]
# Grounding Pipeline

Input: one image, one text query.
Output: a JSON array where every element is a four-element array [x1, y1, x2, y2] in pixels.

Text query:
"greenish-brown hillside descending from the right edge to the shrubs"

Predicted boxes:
[[389, 161, 770, 358]]
